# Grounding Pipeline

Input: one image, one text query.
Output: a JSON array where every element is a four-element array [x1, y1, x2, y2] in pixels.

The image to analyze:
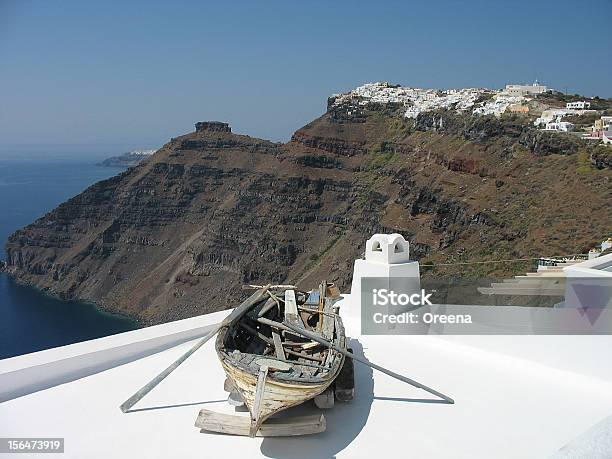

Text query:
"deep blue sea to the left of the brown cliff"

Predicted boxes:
[[0, 157, 137, 359]]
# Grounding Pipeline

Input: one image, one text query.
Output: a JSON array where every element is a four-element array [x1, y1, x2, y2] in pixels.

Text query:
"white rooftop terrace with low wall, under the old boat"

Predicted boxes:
[[0, 295, 612, 458]]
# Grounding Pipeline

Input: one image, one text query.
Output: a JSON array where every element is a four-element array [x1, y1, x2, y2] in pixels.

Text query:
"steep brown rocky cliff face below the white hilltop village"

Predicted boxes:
[[7, 107, 612, 323]]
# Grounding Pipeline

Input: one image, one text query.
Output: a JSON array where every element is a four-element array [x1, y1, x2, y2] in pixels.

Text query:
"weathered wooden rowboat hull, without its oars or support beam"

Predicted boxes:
[[215, 282, 346, 436]]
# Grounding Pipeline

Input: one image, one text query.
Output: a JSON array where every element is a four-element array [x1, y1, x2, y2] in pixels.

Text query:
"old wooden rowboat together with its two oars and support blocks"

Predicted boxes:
[[120, 282, 454, 436]]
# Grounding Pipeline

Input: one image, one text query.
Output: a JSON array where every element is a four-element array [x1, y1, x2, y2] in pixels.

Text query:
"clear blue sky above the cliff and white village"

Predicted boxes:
[[0, 0, 612, 154]]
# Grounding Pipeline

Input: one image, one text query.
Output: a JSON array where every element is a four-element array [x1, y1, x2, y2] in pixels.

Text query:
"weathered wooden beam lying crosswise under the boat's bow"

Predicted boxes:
[[195, 409, 326, 437]]
